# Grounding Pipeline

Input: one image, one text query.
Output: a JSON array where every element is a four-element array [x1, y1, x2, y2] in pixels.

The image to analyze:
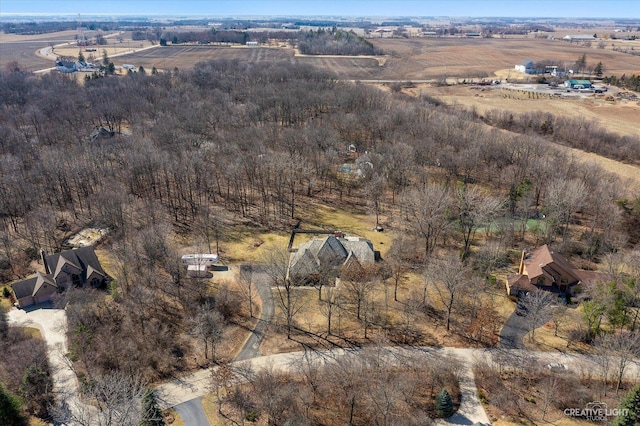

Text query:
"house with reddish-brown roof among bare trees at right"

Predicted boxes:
[[506, 244, 605, 296]]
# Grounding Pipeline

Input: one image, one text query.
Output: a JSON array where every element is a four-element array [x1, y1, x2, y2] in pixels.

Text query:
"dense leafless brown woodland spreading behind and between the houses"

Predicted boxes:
[[0, 61, 640, 422]]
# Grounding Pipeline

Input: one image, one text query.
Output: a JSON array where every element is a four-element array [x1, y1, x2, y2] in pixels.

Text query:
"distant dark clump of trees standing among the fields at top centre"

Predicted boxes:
[[298, 29, 382, 55]]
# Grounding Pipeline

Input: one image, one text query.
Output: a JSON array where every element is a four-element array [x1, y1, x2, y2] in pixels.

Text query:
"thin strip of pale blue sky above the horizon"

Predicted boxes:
[[0, 0, 640, 18]]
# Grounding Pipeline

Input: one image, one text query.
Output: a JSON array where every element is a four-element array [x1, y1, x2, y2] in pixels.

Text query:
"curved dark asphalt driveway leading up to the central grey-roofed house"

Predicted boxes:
[[235, 265, 274, 361]]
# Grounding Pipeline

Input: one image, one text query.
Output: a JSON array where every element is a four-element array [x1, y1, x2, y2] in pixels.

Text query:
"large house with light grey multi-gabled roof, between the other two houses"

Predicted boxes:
[[288, 235, 379, 283]]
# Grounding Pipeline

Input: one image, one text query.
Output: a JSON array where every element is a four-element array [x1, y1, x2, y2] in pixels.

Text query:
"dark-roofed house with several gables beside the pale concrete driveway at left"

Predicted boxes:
[[11, 247, 107, 308]]
